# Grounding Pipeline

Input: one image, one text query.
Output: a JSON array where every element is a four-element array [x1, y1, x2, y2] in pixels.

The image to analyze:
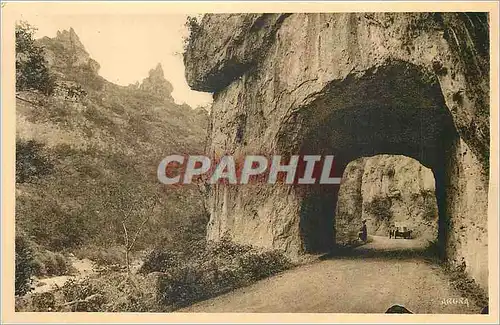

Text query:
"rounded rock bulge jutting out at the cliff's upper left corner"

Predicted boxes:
[[184, 14, 288, 92]]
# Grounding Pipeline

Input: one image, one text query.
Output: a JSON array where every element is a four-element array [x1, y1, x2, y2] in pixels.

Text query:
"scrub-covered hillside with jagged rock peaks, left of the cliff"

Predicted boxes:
[[16, 29, 207, 251]]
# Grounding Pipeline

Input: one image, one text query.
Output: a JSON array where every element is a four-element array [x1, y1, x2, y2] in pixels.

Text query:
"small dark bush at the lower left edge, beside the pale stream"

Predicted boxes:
[[15, 234, 34, 296]]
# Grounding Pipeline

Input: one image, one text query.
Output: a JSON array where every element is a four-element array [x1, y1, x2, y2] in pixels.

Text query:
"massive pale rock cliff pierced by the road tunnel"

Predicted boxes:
[[184, 13, 489, 288]]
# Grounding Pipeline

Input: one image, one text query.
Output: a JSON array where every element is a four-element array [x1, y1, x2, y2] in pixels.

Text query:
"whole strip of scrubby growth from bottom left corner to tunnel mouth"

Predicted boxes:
[[16, 240, 292, 312]]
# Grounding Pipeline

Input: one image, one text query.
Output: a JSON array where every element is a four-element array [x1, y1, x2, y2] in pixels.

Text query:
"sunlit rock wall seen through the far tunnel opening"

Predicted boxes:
[[335, 155, 438, 243]]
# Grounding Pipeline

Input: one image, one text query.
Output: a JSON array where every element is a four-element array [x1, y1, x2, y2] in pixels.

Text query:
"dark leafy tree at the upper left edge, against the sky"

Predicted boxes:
[[16, 21, 55, 95]]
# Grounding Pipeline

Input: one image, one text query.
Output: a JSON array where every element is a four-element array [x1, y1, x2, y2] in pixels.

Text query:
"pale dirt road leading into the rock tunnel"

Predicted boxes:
[[179, 237, 480, 314]]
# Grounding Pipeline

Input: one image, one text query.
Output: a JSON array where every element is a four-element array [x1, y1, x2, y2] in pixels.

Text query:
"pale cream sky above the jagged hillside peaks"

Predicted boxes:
[[15, 11, 212, 108]]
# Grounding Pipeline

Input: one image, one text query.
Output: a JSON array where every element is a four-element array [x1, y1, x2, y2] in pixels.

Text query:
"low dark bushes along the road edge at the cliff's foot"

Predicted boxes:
[[146, 239, 292, 309]]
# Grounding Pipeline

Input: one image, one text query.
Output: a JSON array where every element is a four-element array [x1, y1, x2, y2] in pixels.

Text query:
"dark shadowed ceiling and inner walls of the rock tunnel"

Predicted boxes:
[[280, 61, 458, 257]]
